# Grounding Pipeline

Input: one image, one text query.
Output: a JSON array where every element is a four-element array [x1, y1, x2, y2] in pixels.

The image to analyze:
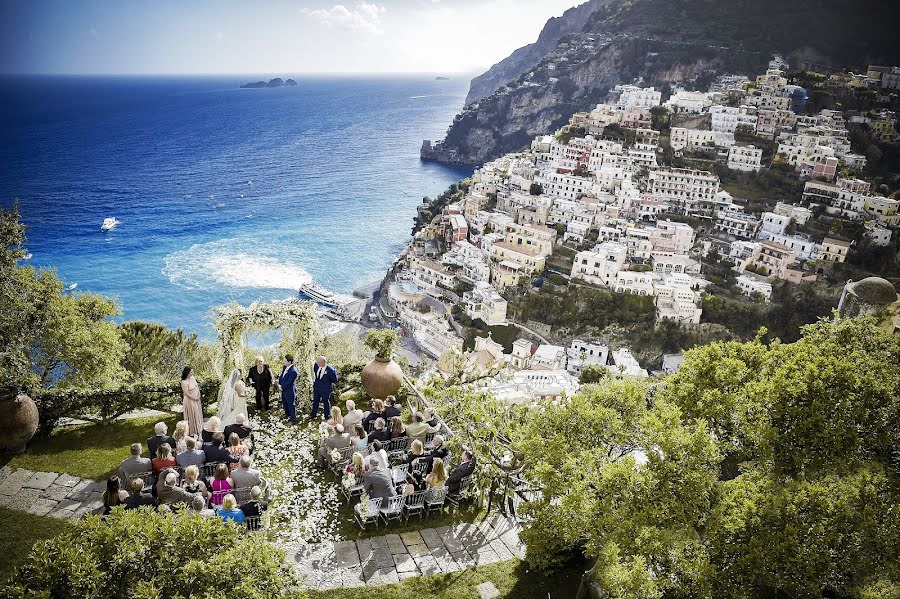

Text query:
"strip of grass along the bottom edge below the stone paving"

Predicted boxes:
[[309, 560, 589, 599]]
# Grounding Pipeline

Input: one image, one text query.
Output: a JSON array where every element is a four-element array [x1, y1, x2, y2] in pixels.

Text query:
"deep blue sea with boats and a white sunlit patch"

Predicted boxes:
[[0, 75, 471, 337]]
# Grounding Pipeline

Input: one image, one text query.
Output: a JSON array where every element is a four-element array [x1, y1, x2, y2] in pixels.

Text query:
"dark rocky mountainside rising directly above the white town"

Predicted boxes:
[[422, 0, 900, 165]]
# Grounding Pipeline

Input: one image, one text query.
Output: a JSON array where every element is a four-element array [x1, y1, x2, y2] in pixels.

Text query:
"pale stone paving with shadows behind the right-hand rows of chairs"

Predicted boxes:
[[287, 514, 525, 589]]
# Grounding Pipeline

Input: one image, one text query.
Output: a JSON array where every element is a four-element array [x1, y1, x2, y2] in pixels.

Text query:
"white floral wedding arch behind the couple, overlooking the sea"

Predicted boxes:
[[213, 301, 322, 413]]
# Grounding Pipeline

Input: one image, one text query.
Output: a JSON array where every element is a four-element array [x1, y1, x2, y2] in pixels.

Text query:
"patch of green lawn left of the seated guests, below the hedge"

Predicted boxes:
[[9, 415, 179, 480]]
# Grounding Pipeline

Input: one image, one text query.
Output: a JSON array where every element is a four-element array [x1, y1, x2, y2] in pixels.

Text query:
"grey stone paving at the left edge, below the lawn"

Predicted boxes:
[[0, 466, 105, 518]]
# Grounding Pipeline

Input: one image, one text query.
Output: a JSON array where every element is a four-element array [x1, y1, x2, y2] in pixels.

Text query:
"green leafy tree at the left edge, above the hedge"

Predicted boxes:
[[0, 208, 125, 388]]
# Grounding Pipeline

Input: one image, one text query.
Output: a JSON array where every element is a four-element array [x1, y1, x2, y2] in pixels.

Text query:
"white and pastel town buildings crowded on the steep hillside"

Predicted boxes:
[[380, 57, 900, 401]]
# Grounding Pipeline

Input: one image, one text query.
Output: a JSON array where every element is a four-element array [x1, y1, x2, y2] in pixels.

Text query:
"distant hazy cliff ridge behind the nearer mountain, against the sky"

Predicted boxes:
[[466, 0, 612, 105]]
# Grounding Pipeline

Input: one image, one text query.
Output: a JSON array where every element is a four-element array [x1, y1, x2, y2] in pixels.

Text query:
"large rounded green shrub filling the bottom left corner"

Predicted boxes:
[[0, 508, 306, 599]]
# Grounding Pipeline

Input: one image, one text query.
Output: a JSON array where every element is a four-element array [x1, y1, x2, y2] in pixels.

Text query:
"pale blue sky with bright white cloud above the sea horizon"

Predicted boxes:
[[0, 0, 579, 74]]
